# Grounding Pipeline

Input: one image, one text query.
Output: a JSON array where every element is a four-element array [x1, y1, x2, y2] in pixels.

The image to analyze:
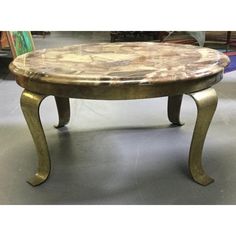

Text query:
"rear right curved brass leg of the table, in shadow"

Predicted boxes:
[[168, 95, 184, 126]]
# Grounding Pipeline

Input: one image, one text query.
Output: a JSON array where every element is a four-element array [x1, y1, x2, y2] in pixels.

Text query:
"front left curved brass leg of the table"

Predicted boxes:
[[21, 90, 50, 186]]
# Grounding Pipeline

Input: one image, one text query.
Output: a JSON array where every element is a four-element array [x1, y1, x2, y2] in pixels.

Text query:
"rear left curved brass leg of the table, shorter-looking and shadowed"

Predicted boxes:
[[54, 96, 70, 129]]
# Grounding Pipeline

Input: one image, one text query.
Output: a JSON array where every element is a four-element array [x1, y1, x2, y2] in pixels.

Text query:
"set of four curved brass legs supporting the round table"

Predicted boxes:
[[21, 88, 217, 186]]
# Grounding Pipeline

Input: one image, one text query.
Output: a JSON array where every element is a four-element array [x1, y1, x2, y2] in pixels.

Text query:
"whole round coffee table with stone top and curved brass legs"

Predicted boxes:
[[9, 42, 229, 186]]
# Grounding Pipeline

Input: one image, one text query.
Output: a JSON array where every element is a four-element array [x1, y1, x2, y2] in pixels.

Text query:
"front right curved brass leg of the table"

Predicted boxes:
[[189, 88, 218, 186]]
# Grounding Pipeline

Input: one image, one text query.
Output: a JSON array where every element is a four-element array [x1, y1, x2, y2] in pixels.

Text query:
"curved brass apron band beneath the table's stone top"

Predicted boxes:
[[16, 73, 223, 100]]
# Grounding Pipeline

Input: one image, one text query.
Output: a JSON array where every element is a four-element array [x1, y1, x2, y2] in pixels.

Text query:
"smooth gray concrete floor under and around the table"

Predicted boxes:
[[0, 32, 236, 204]]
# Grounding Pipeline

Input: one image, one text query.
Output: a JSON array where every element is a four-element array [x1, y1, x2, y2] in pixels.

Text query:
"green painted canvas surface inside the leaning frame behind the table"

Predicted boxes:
[[12, 31, 34, 56]]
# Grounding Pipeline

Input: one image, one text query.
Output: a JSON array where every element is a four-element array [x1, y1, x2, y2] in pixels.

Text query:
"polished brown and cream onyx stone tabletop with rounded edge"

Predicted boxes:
[[10, 42, 229, 85]]
